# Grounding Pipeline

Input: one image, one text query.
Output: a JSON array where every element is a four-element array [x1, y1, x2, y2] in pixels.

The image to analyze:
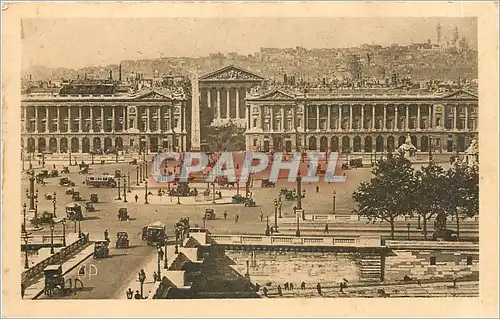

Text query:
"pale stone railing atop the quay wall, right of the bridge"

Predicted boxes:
[[210, 235, 381, 247]]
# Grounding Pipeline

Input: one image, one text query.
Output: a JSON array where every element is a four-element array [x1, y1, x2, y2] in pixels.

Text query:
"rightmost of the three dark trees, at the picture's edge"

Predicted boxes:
[[444, 162, 479, 238]]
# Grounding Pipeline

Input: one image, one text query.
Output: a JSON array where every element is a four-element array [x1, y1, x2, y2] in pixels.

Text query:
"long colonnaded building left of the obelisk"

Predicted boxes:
[[21, 81, 191, 153]]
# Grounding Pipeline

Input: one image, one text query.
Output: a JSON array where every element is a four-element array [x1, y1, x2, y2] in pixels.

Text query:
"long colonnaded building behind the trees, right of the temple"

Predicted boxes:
[[246, 89, 478, 153]]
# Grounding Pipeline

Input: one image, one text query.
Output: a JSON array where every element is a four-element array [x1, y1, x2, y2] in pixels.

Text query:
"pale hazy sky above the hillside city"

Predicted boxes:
[[22, 18, 477, 69]]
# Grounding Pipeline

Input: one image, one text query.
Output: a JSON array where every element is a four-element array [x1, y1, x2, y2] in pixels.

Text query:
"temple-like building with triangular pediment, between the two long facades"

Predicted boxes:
[[199, 65, 264, 127]]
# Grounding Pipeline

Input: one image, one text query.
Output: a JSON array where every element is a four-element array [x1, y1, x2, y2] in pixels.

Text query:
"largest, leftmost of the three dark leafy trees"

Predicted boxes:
[[353, 154, 415, 239]]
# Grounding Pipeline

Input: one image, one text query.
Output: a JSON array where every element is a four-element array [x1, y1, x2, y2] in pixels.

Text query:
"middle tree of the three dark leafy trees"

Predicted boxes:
[[414, 162, 447, 240]]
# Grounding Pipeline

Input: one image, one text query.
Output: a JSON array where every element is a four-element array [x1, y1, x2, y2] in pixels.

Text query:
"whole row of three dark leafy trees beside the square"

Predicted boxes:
[[353, 154, 479, 239]]
